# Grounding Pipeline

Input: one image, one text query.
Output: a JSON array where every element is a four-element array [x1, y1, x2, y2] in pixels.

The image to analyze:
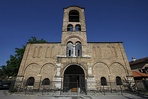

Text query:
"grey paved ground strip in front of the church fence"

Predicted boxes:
[[0, 90, 148, 99]]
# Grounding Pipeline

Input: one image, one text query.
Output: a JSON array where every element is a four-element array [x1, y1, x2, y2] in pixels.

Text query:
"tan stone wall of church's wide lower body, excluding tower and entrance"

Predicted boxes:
[[15, 42, 131, 89]]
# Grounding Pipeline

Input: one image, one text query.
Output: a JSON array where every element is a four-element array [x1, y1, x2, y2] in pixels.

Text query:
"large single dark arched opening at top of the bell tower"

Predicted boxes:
[[69, 10, 79, 22]]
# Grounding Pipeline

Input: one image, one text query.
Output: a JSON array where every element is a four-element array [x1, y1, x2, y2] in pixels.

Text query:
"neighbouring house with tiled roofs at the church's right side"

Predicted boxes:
[[129, 57, 148, 90]]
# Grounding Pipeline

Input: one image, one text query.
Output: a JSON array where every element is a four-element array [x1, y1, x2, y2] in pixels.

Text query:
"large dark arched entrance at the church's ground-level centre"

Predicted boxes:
[[63, 65, 85, 91]]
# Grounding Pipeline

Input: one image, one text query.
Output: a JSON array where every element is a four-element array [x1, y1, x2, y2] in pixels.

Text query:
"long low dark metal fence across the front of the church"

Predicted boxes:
[[12, 81, 140, 95]]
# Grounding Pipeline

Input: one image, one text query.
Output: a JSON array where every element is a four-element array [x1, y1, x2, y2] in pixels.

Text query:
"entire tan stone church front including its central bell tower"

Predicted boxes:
[[15, 6, 132, 91]]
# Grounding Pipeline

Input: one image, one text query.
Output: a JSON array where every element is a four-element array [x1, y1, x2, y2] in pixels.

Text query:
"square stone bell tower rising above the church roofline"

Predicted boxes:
[[61, 6, 87, 46]]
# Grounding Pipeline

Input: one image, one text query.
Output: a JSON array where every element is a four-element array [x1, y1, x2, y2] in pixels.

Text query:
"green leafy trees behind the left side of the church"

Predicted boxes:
[[0, 37, 46, 78]]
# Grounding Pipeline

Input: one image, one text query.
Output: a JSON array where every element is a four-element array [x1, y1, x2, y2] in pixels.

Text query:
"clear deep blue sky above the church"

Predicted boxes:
[[0, 0, 148, 66]]
